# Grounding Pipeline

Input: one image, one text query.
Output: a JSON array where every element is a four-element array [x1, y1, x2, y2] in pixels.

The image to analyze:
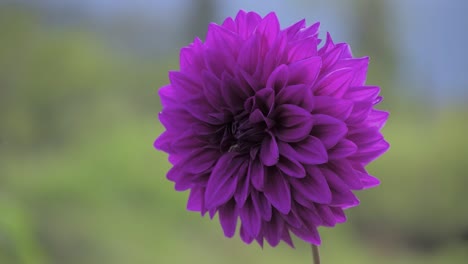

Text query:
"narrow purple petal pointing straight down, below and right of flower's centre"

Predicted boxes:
[[264, 168, 291, 214]]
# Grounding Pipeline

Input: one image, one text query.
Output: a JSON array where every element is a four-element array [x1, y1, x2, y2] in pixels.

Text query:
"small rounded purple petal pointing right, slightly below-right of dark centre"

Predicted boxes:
[[291, 136, 328, 165]]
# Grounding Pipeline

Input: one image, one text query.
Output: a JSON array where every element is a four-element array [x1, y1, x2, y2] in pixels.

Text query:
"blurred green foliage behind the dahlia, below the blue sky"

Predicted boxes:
[[0, 4, 468, 264]]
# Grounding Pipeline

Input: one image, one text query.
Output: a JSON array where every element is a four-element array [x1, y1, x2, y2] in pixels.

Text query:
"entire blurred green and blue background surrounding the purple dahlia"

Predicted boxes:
[[0, 0, 468, 264]]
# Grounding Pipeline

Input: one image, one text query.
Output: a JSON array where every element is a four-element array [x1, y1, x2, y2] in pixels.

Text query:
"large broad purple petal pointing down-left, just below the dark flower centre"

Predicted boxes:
[[205, 152, 247, 209]]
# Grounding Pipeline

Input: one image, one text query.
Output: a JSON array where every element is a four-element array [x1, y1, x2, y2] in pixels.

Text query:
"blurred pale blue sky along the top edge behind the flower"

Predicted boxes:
[[18, 0, 468, 102]]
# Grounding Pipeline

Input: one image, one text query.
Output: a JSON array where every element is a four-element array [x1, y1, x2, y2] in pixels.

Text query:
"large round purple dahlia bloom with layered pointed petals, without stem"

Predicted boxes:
[[155, 11, 389, 246]]
